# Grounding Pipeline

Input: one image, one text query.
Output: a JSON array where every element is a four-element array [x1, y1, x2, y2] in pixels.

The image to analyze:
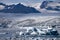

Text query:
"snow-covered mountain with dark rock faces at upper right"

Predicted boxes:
[[34, 1, 60, 13]]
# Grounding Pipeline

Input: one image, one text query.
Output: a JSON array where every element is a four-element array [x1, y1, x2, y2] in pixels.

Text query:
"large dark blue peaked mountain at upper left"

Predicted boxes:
[[0, 3, 40, 13]]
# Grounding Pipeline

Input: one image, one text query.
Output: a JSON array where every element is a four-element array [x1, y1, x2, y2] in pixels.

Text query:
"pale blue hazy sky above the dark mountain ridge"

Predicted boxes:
[[0, 0, 58, 5]]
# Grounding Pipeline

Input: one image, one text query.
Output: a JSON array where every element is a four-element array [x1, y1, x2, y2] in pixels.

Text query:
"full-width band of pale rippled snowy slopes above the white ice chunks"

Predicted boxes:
[[0, 17, 60, 28]]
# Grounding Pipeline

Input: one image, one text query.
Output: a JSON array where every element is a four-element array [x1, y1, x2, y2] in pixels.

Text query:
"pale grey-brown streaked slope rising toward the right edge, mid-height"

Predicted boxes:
[[41, 18, 60, 26]]
